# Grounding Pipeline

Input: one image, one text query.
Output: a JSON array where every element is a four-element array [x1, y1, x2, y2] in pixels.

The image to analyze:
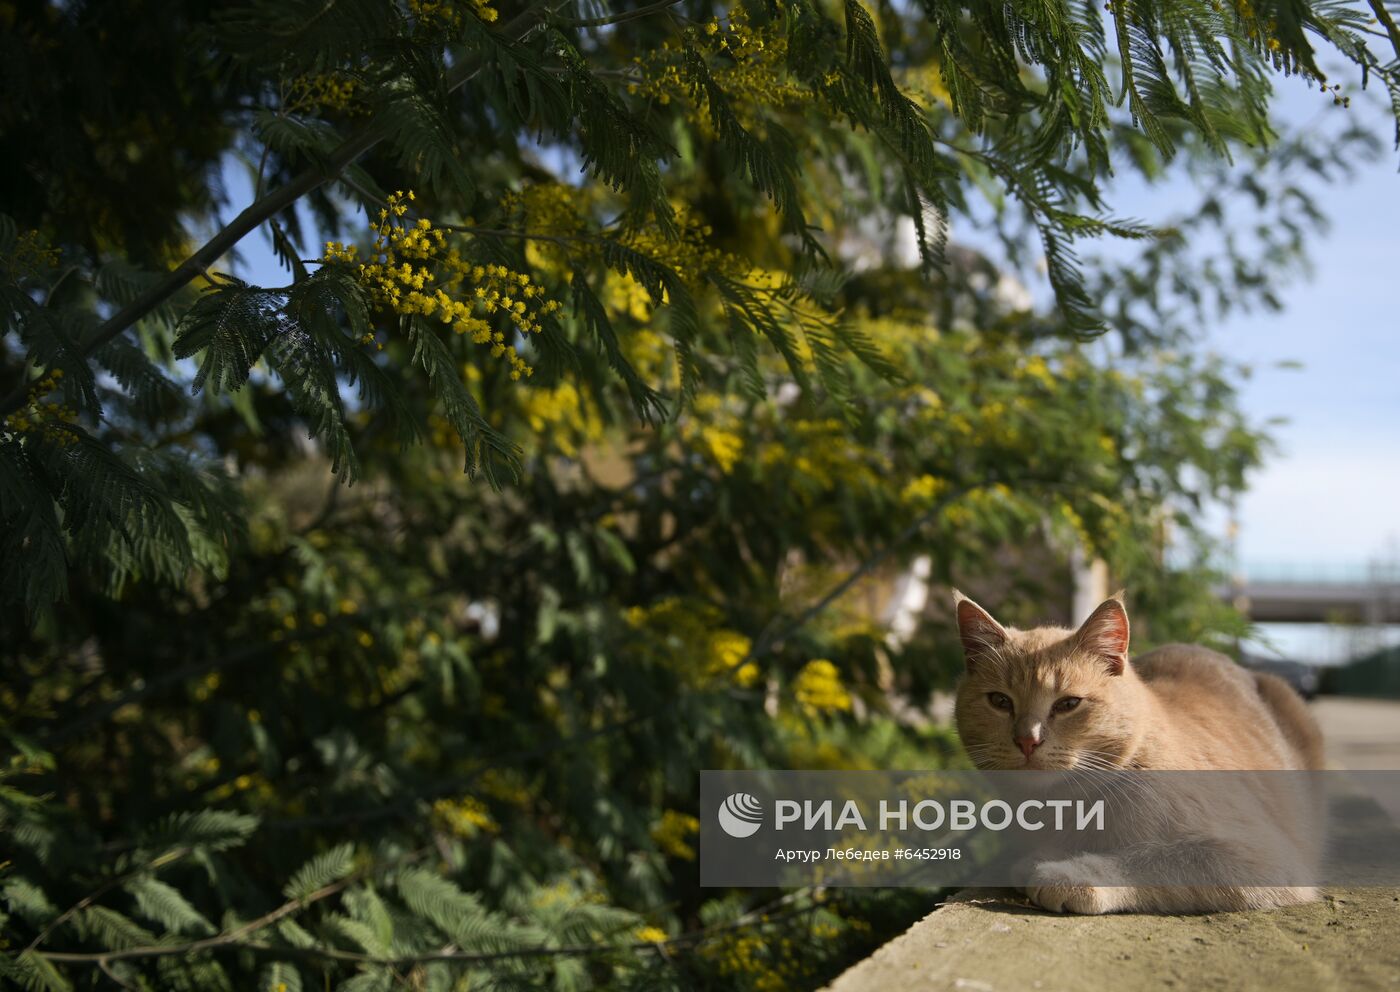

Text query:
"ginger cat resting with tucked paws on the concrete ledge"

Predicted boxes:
[[953, 592, 1323, 914]]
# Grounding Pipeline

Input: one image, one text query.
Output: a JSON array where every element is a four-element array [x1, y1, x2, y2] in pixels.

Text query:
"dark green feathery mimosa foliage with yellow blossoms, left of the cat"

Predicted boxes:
[[0, 0, 1400, 992]]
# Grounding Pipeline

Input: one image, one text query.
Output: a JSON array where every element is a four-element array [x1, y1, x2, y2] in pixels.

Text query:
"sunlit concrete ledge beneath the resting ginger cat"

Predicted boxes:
[[827, 888, 1400, 992]]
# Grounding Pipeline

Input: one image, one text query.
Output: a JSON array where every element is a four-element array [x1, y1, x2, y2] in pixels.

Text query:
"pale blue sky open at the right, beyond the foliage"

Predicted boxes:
[[1114, 80, 1400, 565]]
